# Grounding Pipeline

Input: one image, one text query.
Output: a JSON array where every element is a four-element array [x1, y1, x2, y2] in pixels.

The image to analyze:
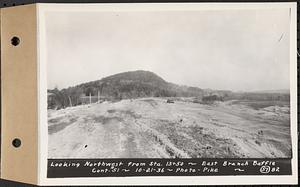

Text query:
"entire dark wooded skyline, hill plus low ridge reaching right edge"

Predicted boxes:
[[48, 70, 290, 109]]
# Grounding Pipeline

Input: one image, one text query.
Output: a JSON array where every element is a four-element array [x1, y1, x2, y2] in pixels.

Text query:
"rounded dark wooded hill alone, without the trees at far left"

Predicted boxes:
[[76, 70, 203, 99]]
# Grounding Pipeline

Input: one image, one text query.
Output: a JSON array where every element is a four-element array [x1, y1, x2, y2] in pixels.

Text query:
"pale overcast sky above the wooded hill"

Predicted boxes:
[[45, 9, 289, 91]]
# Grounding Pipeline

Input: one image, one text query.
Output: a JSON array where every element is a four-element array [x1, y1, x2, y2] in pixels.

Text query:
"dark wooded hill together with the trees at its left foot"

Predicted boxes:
[[48, 70, 205, 107]]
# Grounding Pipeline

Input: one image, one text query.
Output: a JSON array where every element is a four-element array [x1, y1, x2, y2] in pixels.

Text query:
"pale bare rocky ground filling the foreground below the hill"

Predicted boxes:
[[48, 98, 291, 158]]
